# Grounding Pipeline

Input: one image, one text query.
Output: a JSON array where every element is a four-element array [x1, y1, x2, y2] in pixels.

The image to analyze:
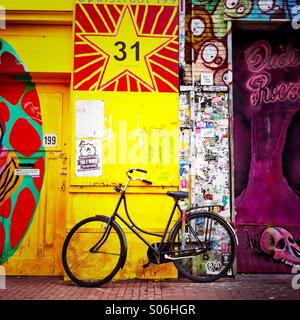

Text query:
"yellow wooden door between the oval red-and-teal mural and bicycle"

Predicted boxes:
[[5, 84, 69, 275]]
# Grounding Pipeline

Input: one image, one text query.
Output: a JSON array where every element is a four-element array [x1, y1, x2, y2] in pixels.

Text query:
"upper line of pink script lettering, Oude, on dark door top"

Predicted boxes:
[[245, 40, 300, 72]]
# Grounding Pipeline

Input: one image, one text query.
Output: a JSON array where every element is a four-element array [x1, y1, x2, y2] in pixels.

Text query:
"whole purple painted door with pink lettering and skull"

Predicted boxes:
[[233, 29, 300, 272]]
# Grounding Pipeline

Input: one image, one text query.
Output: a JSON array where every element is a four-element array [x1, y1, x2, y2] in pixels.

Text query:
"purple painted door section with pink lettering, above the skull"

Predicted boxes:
[[234, 33, 300, 226]]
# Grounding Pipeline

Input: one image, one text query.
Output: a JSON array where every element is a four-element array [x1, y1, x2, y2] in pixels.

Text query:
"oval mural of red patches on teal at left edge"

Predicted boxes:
[[0, 39, 45, 264]]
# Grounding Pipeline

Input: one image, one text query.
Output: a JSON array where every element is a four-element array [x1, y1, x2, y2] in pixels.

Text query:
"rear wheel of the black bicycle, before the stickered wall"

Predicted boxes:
[[170, 212, 236, 282]]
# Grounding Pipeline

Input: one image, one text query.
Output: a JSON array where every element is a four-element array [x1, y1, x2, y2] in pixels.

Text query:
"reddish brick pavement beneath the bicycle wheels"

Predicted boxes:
[[0, 274, 300, 300]]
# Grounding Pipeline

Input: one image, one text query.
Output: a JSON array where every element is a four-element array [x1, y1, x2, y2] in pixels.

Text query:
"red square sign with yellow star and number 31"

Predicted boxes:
[[74, 1, 178, 92]]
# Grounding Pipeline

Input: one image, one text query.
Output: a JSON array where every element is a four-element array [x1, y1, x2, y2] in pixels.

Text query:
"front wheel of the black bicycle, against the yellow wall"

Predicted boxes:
[[62, 216, 127, 287]]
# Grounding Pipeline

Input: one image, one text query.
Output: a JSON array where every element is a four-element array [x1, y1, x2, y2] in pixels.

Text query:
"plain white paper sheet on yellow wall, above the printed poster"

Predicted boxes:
[[76, 100, 104, 138]]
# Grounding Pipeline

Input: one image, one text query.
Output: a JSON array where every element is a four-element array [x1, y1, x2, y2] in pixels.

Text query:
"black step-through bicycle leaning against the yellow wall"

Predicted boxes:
[[62, 168, 237, 287]]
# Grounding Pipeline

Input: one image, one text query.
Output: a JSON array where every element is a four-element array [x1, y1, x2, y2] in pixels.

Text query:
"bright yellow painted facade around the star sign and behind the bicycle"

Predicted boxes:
[[0, 0, 178, 279]]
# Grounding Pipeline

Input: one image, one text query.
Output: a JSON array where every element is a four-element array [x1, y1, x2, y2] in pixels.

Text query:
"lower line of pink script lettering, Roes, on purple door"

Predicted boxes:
[[246, 73, 300, 105]]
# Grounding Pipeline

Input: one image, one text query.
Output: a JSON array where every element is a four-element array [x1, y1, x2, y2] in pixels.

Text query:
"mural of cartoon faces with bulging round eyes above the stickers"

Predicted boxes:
[[180, 0, 300, 85]]
